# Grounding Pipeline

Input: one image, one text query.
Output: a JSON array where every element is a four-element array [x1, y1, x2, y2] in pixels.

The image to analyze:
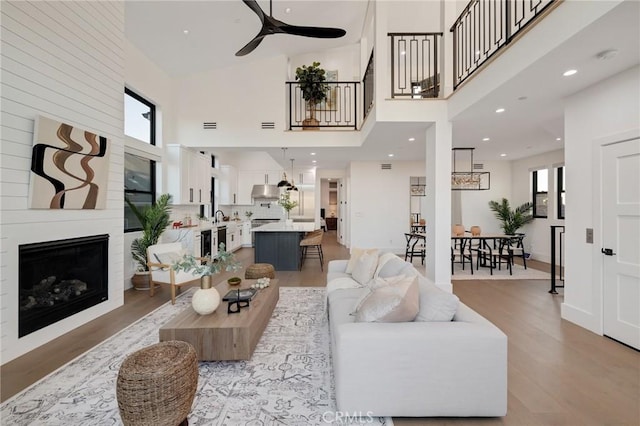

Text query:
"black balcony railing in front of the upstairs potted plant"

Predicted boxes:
[[286, 81, 361, 130]]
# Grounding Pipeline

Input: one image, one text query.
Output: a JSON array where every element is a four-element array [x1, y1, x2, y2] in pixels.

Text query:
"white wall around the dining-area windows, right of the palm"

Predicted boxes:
[[509, 150, 573, 263]]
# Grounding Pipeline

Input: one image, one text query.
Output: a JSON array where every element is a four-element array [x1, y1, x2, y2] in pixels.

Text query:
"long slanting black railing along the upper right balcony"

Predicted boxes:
[[451, 0, 557, 90]]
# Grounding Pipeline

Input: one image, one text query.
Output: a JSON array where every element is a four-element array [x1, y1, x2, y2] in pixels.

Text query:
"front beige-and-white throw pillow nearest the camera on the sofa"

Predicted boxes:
[[355, 277, 420, 322]]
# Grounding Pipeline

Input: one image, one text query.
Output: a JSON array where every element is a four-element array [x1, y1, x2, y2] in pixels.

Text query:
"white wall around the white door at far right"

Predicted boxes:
[[562, 67, 640, 334]]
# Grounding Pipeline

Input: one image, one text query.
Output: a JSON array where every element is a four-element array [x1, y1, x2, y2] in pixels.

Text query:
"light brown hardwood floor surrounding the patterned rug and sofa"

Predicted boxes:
[[0, 231, 640, 426]]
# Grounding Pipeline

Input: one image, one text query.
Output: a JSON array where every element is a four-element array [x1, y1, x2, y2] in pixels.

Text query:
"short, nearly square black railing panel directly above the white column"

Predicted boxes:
[[388, 33, 442, 98]]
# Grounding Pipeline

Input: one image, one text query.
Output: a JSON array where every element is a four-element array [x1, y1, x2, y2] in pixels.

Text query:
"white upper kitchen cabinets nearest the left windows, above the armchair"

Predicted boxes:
[[166, 145, 211, 205]]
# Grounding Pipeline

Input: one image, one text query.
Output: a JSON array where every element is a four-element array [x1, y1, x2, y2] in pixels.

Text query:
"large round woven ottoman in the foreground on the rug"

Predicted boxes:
[[116, 341, 198, 426]]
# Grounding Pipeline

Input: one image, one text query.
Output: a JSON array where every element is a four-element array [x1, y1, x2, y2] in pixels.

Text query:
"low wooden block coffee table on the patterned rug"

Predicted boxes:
[[160, 279, 280, 361]]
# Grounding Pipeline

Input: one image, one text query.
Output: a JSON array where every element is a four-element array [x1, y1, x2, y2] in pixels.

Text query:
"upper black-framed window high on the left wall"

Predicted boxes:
[[124, 87, 156, 145]]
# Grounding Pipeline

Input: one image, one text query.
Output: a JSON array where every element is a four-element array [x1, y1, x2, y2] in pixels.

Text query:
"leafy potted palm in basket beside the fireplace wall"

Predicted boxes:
[[125, 194, 171, 290]]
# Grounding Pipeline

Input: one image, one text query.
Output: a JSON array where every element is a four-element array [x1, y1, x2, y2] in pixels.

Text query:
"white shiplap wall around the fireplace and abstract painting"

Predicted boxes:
[[0, 1, 124, 364]]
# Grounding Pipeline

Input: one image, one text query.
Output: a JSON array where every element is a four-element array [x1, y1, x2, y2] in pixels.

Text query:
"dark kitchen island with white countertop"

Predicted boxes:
[[251, 222, 315, 271]]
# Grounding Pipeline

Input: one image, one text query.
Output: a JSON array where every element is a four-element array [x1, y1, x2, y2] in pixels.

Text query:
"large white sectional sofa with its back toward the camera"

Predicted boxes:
[[327, 256, 507, 417]]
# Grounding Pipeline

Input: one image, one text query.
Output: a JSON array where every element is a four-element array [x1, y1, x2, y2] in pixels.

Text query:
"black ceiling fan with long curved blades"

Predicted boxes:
[[236, 0, 346, 56]]
